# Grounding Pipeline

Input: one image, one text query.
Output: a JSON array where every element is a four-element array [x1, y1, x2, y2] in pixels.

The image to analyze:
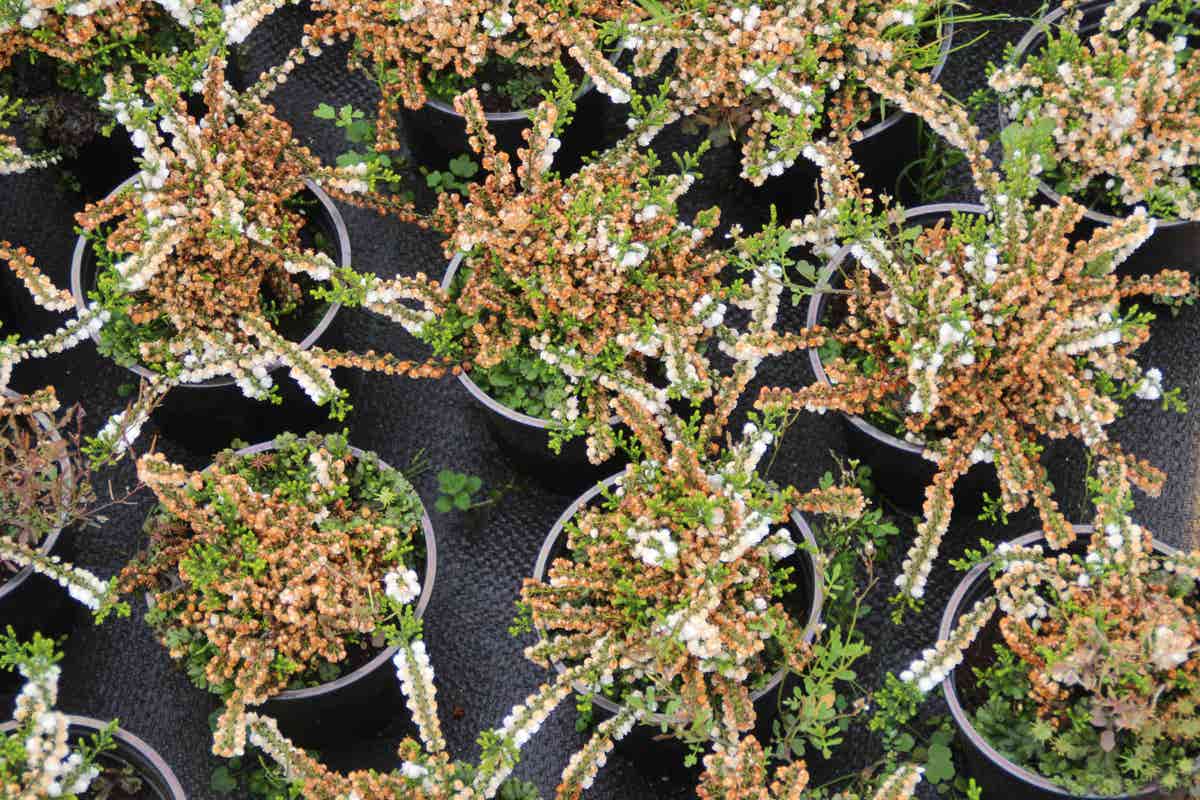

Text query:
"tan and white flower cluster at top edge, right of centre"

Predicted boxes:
[[623, 0, 942, 185]]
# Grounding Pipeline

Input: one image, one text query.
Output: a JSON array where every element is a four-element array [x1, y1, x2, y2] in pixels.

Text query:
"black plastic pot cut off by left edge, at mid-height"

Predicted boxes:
[[0, 389, 76, 696]]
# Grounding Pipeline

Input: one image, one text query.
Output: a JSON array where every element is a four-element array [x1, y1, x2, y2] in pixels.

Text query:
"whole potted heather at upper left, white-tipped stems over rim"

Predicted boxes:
[[2, 60, 446, 462]]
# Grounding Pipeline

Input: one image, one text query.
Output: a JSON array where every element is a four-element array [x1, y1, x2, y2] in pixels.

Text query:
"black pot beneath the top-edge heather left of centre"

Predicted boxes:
[[400, 72, 608, 174]]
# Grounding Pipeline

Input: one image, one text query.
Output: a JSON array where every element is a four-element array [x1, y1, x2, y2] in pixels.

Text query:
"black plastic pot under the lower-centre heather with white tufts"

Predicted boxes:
[[533, 473, 824, 775]]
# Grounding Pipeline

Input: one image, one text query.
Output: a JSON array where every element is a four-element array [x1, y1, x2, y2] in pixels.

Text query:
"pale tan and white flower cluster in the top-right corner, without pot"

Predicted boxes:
[[990, 0, 1200, 219]]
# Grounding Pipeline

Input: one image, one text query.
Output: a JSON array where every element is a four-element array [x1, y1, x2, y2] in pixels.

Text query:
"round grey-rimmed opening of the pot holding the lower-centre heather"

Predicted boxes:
[[533, 473, 824, 727]]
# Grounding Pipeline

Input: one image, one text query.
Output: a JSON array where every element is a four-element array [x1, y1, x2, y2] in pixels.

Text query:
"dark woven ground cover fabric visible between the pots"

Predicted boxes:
[[0, 0, 1200, 800]]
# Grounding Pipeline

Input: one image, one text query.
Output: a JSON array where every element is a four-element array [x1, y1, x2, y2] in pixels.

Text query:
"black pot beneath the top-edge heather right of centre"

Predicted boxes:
[[758, 8, 954, 219]]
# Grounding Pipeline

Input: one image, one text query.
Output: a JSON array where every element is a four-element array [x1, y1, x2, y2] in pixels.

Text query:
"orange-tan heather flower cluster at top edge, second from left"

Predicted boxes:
[[226, 0, 630, 150]]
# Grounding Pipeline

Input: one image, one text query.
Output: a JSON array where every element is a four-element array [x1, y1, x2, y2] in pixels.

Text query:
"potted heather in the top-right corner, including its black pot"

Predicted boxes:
[[989, 0, 1200, 278]]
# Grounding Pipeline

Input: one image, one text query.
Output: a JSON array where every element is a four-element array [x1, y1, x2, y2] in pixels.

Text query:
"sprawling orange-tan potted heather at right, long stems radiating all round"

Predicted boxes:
[[757, 109, 1190, 604]]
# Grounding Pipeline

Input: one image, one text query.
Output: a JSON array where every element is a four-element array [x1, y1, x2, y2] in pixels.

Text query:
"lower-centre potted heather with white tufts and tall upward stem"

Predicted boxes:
[[518, 266, 864, 777]]
